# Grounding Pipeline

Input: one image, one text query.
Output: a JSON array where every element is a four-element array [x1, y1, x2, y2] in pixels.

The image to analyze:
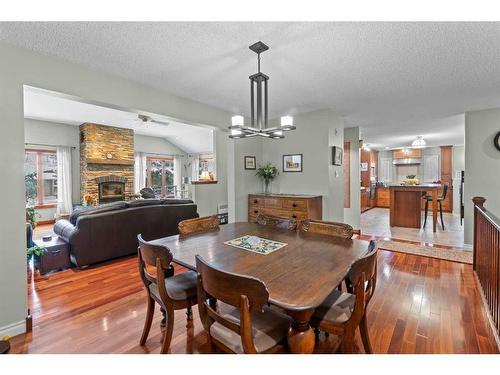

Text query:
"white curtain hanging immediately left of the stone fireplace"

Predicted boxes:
[[56, 146, 73, 216]]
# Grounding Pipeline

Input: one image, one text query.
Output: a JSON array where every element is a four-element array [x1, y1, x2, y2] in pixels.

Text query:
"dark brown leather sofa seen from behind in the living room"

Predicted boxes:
[[54, 199, 199, 267]]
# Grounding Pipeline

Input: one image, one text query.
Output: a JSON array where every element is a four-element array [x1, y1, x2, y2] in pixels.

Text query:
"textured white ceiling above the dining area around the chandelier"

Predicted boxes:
[[0, 22, 500, 147]]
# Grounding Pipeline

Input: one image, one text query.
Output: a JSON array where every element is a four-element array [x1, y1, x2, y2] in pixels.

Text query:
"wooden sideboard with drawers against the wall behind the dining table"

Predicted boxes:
[[248, 194, 323, 223]]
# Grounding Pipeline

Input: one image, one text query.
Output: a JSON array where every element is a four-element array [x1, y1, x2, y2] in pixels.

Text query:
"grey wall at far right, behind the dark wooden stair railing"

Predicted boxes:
[[464, 108, 500, 245]]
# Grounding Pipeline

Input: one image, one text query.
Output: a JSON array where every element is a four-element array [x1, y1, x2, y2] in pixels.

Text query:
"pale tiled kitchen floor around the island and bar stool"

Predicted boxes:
[[361, 207, 464, 248]]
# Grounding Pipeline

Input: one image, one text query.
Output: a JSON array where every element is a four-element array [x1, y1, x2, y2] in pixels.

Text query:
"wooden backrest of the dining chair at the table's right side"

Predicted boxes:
[[346, 241, 378, 305]]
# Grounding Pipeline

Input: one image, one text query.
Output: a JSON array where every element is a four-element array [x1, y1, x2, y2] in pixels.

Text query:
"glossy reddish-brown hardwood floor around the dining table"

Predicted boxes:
[[11, 250, 498, 353]]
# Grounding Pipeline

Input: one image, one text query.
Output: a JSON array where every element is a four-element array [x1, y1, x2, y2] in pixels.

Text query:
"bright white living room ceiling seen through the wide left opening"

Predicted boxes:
[[24, 89, 213, 153]]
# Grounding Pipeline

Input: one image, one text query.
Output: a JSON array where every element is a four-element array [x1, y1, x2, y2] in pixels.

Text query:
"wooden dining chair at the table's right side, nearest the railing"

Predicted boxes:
[[311, 241, 377, 354]]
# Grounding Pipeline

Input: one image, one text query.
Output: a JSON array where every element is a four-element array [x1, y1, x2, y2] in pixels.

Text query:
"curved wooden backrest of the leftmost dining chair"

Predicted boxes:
[[137, 234, 172, 306]]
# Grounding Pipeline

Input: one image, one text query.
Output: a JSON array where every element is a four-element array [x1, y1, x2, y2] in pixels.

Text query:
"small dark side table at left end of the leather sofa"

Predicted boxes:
[[34, 235, 71, 275]]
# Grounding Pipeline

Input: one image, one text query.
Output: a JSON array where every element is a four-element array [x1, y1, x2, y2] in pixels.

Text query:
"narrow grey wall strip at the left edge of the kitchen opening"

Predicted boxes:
[[344, 127, 361, 229]]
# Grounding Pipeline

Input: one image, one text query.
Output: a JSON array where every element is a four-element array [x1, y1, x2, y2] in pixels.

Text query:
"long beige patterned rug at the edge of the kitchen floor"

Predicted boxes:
[[377, 240, 473, 264]]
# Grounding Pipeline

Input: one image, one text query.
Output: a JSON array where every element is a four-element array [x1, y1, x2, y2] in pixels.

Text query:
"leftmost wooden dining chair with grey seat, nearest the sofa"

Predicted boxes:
[[137, 234, 197, 354]]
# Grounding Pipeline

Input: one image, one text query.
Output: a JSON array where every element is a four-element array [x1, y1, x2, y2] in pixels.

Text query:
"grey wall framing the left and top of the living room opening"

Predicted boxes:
[[0, 42, 231, 336]]
